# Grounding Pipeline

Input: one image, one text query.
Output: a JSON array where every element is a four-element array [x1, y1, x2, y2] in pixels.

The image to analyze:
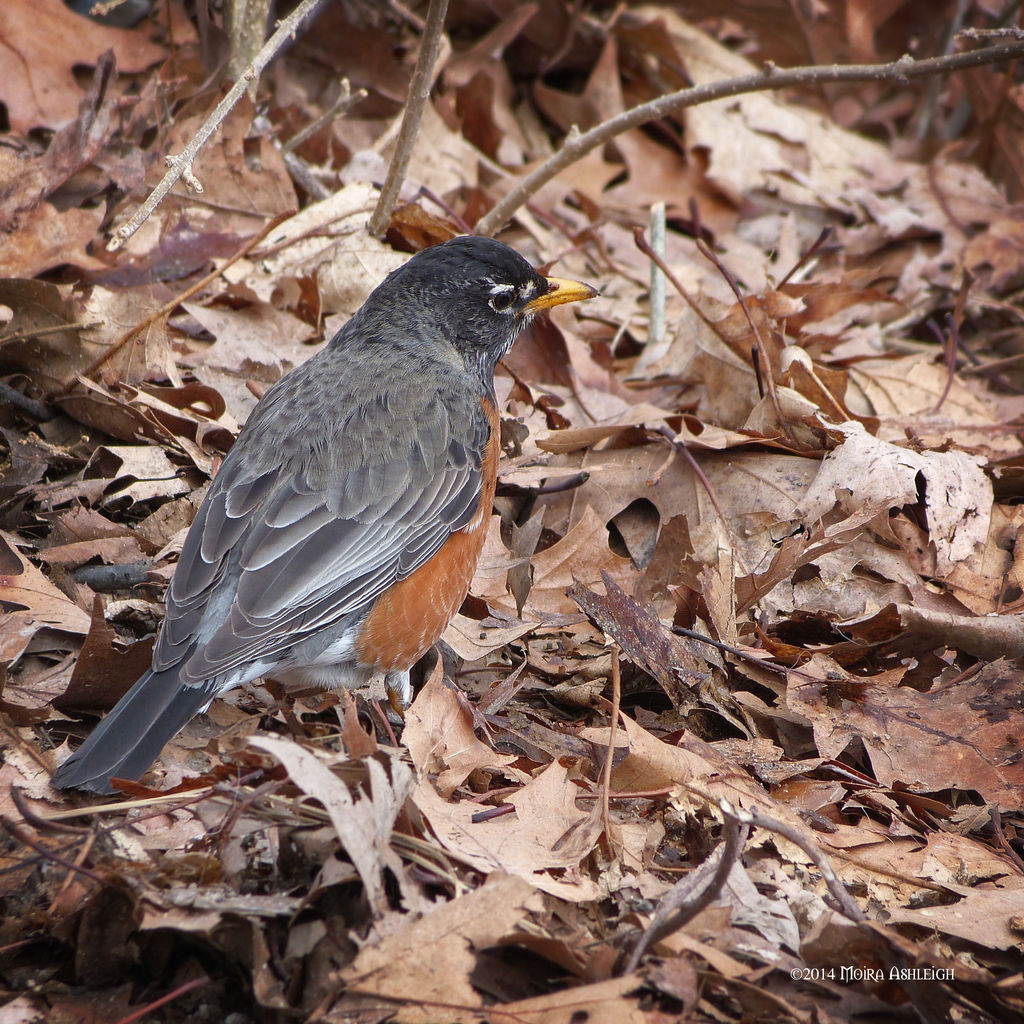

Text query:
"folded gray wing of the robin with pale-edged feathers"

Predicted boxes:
[[154, 370, 489, 683]]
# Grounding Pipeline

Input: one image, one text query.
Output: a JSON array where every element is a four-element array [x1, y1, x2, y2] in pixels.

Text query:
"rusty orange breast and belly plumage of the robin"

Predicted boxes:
[[355, 398, 500, 672]]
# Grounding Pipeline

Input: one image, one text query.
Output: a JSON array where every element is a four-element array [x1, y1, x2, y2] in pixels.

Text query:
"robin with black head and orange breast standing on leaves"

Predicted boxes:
[[51, 236, 597, 794]]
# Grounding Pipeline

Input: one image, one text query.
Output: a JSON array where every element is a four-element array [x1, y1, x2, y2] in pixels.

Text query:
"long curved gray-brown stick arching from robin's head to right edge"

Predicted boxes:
[[476, 42, 1024, 234]]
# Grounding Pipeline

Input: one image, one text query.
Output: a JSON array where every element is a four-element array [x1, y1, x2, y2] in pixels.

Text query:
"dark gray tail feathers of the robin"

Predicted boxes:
[[51, 670, 215, 793]]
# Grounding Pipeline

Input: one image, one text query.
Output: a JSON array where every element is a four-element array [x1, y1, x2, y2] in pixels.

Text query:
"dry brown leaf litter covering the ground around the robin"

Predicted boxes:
[[0, 0, 1024, 1024]]
